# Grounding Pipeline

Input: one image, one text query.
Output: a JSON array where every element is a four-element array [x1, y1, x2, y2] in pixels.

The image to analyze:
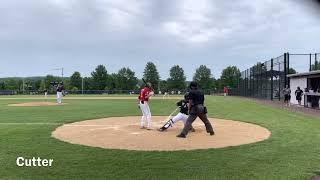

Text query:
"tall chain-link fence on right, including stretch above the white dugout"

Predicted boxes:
[[234, 53, 320, 100]]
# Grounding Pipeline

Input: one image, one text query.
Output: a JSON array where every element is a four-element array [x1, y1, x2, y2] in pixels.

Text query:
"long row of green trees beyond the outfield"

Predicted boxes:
[[0, 62, 241, 92]]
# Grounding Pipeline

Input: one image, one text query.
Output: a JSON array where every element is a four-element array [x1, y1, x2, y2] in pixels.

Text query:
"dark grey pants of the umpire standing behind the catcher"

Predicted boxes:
[[181, 104, 213, 135]]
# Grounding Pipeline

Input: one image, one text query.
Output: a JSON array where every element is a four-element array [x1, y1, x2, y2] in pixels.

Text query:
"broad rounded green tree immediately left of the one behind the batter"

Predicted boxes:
[[116, 68, 138, 90]]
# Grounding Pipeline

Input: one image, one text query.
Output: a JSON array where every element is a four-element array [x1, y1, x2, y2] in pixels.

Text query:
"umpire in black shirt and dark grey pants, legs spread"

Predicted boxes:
[[177, 82, 214, 138]]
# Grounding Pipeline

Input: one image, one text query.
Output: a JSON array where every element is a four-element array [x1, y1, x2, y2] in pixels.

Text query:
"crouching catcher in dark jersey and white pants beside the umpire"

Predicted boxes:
[[159, 93, 195, 132]]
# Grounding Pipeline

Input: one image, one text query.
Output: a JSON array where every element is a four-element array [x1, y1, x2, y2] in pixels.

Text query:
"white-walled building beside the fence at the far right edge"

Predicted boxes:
[[288, 70, 320, 105]]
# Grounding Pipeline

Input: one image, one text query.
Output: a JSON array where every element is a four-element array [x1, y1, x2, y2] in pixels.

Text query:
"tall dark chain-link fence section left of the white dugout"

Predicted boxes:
[[232, 53, 289, 100]]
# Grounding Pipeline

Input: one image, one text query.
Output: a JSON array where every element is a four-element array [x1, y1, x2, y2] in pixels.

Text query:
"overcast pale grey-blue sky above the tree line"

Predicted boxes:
[[0, 0, 320, 79]]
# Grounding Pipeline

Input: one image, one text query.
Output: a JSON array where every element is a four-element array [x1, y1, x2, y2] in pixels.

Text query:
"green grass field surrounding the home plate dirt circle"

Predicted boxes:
[[0, 97, 320, 179]]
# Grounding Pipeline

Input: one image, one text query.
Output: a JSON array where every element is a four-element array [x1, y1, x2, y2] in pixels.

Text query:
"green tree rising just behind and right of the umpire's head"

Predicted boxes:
[[193, 65, 214, 90]]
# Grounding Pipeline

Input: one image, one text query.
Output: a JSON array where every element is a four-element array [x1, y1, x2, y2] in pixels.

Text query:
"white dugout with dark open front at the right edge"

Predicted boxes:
[[288, 70, 320, 108]]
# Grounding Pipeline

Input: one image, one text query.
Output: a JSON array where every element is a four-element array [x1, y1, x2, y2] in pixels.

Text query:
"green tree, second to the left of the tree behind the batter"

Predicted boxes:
[[91, 65, 108, 90]]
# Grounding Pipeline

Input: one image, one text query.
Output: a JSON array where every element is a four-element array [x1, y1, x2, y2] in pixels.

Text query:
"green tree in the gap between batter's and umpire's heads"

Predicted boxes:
[[167, 65, 186, 90]]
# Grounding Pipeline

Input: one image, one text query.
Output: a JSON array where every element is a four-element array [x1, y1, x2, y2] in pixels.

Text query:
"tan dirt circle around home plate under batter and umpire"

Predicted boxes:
[[52, 116, 271, 151]]
